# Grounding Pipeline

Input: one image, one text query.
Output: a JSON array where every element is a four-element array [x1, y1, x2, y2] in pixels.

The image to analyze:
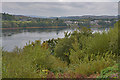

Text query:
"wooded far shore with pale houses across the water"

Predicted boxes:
[[2, 13, 117, 29]]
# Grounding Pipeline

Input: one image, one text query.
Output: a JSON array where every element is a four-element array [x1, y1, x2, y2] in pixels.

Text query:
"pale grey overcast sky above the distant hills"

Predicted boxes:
[[2, 0, 118, 17]]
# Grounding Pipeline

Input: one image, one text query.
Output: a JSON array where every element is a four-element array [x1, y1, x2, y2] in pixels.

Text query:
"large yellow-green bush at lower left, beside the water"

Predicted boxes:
[[3, 40, 66, 78]]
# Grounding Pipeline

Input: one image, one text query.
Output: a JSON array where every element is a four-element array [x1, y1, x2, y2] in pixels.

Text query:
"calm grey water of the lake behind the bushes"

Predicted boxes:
[[0, 28, 108, 51]]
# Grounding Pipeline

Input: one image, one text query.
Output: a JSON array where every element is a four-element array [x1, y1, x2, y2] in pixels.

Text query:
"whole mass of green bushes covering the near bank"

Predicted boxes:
[[2, 20, 120, 78]]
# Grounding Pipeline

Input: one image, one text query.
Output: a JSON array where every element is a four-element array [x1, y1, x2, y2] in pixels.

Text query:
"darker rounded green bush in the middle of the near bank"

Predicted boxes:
[[54, 33, 73, 63]]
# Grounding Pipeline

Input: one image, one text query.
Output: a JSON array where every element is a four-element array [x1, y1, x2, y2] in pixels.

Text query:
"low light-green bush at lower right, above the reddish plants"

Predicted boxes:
[[70, 52, 116, 75]]
